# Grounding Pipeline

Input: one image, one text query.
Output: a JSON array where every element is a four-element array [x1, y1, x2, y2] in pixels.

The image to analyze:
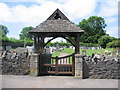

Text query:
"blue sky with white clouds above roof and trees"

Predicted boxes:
[[0, 0, 119, 39]]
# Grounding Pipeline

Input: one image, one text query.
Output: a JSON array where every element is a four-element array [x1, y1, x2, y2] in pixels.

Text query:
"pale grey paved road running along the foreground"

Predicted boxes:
[[2, 75, 118, 88]]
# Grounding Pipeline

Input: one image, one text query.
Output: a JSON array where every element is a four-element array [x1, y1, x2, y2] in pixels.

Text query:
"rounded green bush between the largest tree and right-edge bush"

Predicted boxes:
[[98, 35, 113, 48]]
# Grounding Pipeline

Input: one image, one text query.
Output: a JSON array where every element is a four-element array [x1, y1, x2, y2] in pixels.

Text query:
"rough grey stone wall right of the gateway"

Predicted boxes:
[[84, 55, 120, 79]]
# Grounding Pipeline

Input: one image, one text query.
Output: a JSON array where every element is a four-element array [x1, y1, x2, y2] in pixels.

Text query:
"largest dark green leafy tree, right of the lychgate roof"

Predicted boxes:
[[78, 16, 107, 44]]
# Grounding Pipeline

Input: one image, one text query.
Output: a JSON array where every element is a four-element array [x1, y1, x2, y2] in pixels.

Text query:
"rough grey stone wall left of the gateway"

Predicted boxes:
[[0, 51, 30, 75]]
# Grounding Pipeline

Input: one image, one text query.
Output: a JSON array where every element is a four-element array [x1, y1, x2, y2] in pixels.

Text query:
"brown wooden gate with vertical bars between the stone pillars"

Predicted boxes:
[[40, 54, 75, 75]]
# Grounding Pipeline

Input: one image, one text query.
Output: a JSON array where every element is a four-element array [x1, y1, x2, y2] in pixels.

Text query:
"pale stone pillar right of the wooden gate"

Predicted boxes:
[[75, 54, 83, 79]]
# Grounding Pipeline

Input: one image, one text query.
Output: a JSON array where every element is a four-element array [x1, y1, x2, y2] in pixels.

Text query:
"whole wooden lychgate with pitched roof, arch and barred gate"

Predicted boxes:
[[29, 9, 84, 75]]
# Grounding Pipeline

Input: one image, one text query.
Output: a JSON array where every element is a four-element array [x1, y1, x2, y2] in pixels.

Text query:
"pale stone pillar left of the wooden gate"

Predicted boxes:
[[30, 53, 39, 76]]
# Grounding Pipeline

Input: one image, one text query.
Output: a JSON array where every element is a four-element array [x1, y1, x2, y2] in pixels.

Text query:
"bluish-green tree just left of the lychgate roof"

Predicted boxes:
[[19, 26, 33, 40]]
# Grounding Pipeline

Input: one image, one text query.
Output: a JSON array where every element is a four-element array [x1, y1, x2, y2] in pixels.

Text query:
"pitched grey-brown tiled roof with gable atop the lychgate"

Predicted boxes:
[[29, 9, 84, 33]]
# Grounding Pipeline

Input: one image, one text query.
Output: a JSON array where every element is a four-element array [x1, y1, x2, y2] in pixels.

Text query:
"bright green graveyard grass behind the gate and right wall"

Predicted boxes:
[[52, 48, 113, 57]]
